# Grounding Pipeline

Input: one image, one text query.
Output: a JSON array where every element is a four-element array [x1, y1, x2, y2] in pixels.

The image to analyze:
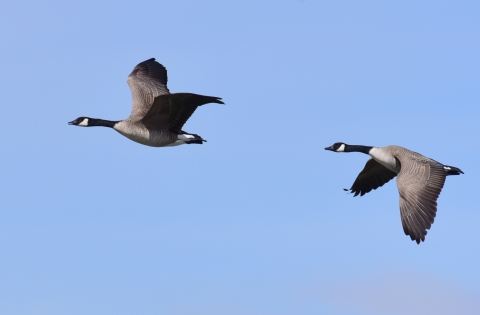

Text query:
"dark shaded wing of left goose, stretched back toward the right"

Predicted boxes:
[[141, 93, 223, 134]]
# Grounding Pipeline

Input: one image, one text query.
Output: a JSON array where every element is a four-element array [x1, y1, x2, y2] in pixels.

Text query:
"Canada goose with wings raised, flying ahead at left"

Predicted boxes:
[[68, 58, 224, 147]]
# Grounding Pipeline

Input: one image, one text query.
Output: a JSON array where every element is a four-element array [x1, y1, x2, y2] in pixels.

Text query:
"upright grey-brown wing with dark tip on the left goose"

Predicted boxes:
[[127, 58, 170, 120]]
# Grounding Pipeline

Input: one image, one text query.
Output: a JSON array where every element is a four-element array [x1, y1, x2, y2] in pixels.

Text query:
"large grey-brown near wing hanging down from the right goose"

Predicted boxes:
[[397, 156, 447, 244]]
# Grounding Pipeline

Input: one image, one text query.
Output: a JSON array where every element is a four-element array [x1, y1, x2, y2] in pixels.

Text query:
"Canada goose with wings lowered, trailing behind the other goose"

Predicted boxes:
[[325, 142, 463, 244]]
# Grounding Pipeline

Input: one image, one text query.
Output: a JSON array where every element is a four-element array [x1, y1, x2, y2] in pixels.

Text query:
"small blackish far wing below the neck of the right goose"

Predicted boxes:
[[350, 159, 397, 197]]
